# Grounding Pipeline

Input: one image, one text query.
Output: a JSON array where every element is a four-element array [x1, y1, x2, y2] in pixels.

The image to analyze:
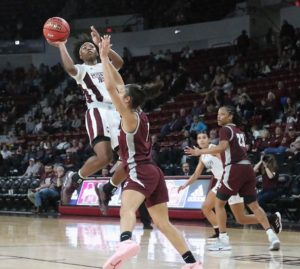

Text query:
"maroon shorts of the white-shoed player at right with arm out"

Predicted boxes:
[[218, 164, 256, 197]]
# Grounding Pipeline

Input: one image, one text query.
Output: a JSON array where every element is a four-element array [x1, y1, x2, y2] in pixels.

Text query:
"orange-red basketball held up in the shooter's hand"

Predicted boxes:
[[43, 17, 70, 42]]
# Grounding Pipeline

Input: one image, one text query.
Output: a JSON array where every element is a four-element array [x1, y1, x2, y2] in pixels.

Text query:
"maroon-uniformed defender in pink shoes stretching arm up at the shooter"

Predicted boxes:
[[100, 36, 202, 269]]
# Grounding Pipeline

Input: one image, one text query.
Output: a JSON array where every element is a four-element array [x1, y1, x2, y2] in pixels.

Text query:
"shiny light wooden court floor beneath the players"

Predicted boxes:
[[0, 216, 300, 269]]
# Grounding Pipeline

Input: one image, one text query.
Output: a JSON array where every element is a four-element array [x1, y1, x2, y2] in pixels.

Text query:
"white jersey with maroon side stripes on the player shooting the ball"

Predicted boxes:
[[72, 63, 112, 108]]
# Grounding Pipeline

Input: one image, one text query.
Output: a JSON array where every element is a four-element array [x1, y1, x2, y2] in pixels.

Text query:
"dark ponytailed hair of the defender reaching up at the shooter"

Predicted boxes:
[[125, 80, 163, 109]]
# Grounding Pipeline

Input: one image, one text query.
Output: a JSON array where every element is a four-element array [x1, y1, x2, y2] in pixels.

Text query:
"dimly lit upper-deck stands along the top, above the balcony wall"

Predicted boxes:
[[0, 0, 240, 40]]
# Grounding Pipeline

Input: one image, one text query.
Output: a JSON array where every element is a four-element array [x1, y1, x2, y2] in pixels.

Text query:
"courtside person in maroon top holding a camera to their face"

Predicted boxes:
[[254, 155, 278, 210]]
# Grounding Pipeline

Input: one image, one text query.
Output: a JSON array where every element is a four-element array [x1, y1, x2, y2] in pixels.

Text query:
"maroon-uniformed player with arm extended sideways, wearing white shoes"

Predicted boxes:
[[185, 106, 280, 251]]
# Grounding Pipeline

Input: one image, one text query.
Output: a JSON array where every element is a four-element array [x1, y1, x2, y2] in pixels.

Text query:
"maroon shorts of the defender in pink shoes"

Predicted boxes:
[[123, 163, 169, 207]]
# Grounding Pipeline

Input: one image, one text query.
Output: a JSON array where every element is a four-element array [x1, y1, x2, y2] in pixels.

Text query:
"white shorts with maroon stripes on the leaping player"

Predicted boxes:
[[85, 104, 121, 149]]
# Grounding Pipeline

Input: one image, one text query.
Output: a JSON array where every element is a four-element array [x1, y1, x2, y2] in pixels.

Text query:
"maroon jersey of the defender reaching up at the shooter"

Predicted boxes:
[[119, 110, 151, 170]]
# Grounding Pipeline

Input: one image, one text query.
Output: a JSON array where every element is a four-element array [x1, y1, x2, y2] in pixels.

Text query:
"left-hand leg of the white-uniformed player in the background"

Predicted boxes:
[[202, 190, 219, 238]]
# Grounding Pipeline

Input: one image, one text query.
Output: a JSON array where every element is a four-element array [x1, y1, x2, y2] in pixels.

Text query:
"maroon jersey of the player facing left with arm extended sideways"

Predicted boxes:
[[219, 124, 248, 166]]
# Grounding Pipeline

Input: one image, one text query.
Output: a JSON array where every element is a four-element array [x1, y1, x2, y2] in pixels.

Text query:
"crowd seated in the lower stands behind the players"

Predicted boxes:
[[0, 19, 300, 215]]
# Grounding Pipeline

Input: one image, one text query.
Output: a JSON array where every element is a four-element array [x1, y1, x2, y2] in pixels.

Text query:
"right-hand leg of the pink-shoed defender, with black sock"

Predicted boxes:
[[148, 203, 202, 269]]
